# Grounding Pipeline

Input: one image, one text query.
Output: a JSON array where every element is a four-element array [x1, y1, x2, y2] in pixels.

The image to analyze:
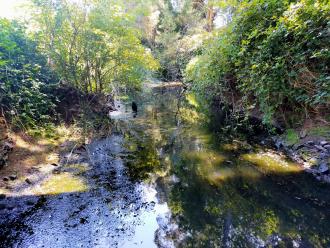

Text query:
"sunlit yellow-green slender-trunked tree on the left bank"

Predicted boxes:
[[34, 0, 157, 92]]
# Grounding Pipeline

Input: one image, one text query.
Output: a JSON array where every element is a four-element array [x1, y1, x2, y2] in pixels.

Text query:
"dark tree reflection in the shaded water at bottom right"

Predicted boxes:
[[169, 150, 330, 247]]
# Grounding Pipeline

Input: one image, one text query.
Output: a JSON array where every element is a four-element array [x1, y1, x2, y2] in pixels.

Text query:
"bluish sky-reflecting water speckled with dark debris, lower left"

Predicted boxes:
[[0, 133, 172, 247]]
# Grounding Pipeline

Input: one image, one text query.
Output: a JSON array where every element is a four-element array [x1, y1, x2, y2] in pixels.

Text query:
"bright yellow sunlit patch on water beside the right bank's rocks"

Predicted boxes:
[[240, 152, 302, 173]]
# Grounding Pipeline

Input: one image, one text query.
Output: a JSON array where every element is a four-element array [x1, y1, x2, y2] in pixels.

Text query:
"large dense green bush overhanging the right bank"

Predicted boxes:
[[186, 0, 330, 125]]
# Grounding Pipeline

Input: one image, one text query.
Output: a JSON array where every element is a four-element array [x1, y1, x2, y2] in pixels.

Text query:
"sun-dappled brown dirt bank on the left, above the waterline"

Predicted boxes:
[[0, 125, 82, 189]]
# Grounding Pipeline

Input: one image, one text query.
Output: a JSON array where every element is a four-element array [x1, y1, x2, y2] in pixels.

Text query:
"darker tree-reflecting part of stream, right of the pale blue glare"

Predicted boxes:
[[114, 84, 330, 247]]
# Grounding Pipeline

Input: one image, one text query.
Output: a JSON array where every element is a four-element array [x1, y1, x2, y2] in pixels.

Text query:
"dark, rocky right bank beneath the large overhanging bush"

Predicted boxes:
[[209, 99, 330, 183]]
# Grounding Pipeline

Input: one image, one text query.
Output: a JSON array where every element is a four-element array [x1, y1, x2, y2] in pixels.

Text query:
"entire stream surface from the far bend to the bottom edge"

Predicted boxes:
[[0, 84, 330, 248]]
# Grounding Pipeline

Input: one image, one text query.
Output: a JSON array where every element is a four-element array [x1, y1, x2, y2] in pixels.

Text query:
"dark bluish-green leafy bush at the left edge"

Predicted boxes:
[[0, 19, 56, 128]]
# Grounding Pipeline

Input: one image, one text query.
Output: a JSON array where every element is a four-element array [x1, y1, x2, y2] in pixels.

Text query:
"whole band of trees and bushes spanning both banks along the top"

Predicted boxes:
[[0, 0, 330, 130]]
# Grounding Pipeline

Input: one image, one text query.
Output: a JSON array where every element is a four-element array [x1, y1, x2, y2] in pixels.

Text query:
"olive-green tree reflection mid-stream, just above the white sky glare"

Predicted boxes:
[[126, 87, 196, 179]]
